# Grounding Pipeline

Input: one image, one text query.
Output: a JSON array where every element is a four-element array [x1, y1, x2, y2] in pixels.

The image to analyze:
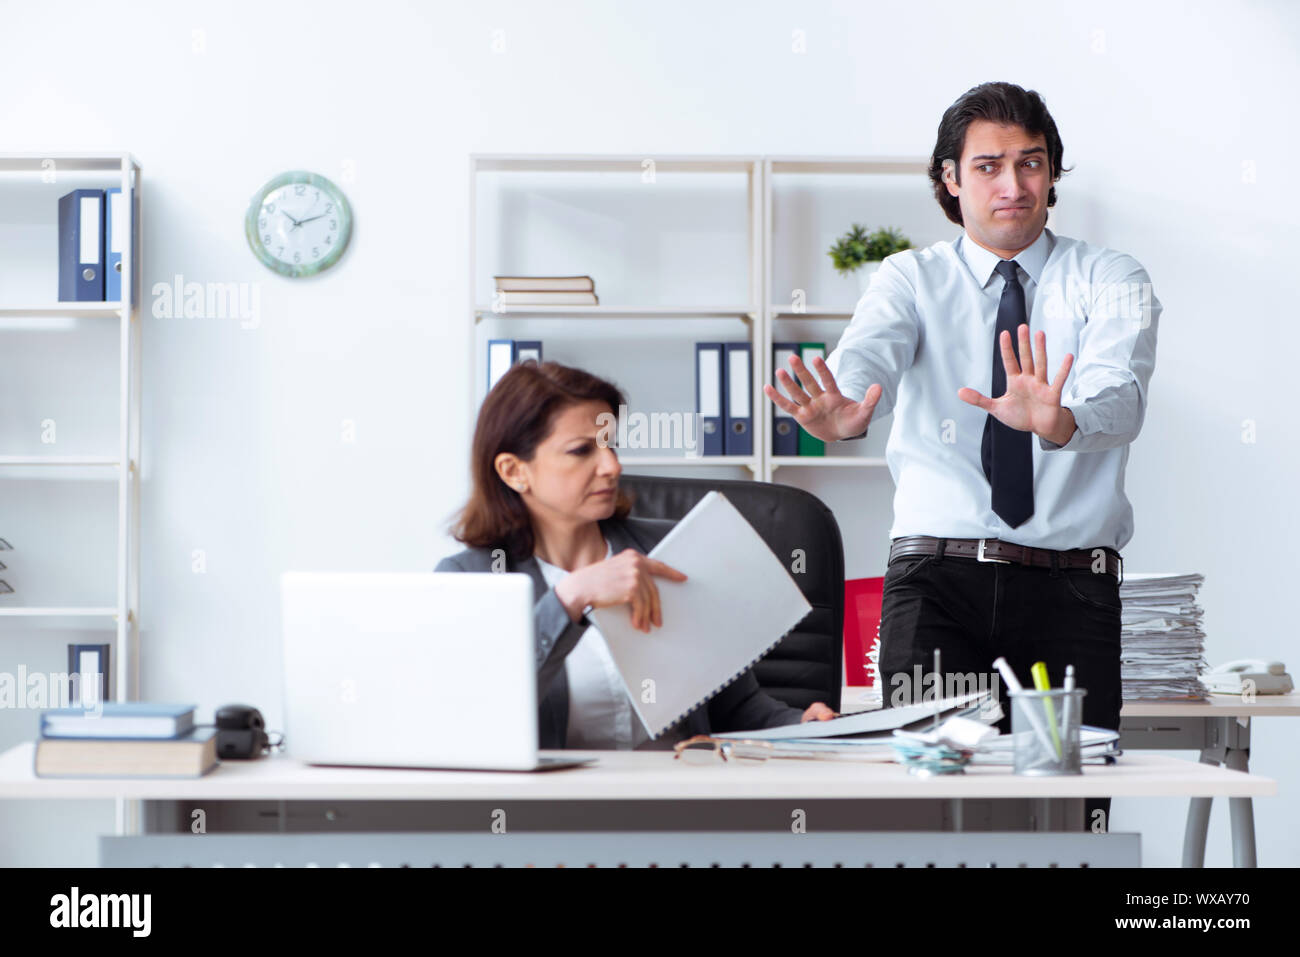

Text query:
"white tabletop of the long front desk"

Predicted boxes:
[[0, 741, 1278, 801]]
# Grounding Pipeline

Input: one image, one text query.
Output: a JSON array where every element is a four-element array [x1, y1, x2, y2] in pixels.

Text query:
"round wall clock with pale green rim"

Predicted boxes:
[[244, 172, 352, 277]]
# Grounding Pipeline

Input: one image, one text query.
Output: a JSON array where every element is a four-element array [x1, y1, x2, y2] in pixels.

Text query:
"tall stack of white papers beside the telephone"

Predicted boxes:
[[1119, 575, 1208, 701]]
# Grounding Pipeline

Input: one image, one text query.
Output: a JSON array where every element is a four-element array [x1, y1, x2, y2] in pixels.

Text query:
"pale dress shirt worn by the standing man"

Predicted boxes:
[[827, 228, 1161, 550]]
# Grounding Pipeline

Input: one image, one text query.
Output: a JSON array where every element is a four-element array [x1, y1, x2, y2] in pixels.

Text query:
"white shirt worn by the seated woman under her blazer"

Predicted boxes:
[[534, 545, 650, 750]]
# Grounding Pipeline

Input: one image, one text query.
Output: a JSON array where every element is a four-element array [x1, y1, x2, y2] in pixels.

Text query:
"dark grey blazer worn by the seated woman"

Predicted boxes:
[[434, 518, 803, 749]]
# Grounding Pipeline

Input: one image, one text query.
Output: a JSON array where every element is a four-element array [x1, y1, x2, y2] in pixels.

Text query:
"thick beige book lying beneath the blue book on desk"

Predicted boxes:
[[35, 727, 217, 778]]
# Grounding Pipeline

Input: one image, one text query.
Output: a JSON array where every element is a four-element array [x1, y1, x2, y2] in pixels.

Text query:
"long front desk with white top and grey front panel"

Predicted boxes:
[[0, 742, 1277, 866]]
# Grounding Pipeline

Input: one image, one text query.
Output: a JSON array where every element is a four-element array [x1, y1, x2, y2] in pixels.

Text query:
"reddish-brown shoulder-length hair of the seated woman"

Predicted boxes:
[[451, 359, 632, 562]]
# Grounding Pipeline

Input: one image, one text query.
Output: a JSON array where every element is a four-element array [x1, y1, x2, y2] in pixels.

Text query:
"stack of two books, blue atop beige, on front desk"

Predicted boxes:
[[36, 701, 217, 778]]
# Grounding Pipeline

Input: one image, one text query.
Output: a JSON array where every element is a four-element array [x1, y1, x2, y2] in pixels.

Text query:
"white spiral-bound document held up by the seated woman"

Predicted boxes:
[[592, 492, 813, 737]]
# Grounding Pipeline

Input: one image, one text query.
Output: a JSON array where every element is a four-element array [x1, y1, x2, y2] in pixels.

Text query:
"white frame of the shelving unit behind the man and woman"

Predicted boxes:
[[469, 153, 928, 481]]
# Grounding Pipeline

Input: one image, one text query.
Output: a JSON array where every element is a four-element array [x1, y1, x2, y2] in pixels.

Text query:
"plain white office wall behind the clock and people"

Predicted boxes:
[[0, 0, 1300, 865]]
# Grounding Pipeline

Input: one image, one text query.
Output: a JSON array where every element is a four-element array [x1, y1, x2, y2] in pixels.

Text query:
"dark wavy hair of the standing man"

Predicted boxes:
[[930, 83, 1070, 226]]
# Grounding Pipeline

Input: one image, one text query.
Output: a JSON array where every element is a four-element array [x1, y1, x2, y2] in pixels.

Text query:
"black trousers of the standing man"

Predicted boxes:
[[879, 540, 1122, 830]]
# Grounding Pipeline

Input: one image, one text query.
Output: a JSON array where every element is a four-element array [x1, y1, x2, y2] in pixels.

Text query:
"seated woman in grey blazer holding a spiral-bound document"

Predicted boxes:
[[436, 361, 835, 750]]
